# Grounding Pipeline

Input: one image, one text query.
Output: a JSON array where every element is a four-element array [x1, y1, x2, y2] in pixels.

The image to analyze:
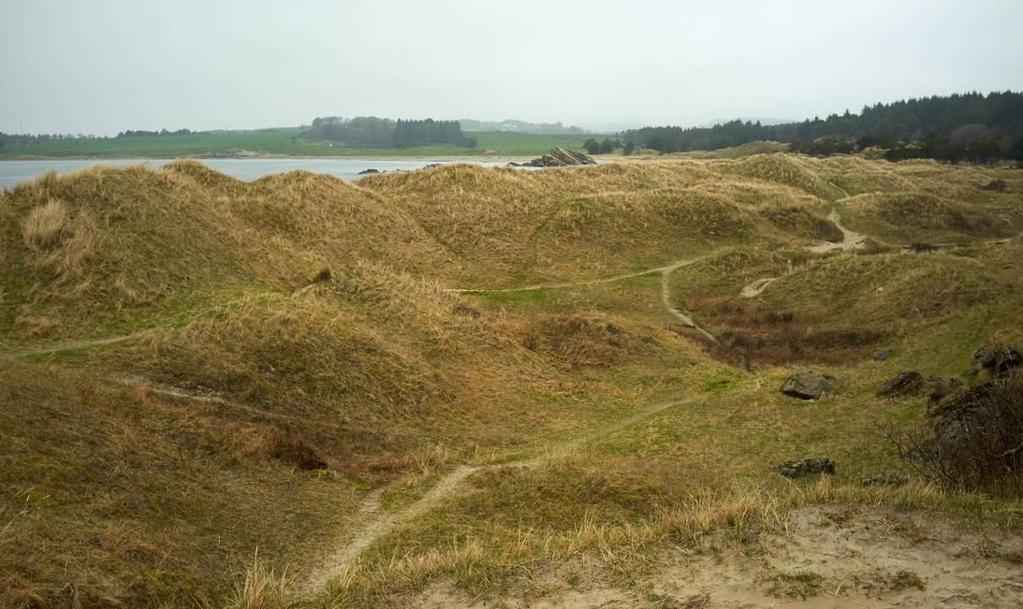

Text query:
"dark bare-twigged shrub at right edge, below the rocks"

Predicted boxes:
[[893, 378, 1023, 492]]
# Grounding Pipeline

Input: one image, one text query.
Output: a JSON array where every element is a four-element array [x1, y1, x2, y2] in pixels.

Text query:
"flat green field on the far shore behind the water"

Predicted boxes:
[[0, 127, 588, 159]]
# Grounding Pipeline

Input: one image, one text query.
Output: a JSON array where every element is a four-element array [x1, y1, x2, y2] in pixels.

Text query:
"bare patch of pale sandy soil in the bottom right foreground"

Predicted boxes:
[[408, 506, 1023, 609]]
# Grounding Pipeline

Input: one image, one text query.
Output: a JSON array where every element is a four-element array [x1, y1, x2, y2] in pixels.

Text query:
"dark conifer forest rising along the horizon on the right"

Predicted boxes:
[[621, 91, 1023, 163]]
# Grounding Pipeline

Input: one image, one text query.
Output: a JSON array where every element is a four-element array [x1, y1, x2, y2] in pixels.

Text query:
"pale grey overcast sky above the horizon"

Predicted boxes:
[[0, 0, 1023, 134]]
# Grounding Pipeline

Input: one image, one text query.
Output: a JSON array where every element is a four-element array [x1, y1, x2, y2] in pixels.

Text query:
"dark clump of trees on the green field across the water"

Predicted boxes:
[[302, 117, 476, 148]]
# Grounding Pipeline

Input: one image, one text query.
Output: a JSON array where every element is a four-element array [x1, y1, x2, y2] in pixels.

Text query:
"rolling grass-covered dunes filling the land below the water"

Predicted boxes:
[[0, 155, 1023, 607]]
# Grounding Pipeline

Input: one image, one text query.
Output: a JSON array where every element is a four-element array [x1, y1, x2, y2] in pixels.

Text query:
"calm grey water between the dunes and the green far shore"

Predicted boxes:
[[0, 159, 507, 187]]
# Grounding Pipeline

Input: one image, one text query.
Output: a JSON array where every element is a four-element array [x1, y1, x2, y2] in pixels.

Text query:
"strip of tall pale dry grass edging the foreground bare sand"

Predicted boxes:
[[312, 480, 973, 608]]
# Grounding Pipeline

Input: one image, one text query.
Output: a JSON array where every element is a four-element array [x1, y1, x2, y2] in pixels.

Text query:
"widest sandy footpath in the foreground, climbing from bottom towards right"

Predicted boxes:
[[299, 396, 700, 596]]
